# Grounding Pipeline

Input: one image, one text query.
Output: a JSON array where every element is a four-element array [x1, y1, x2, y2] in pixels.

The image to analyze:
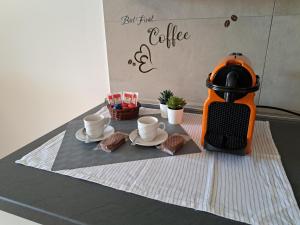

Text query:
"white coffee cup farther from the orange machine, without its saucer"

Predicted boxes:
[[83, 114, 111, 138]]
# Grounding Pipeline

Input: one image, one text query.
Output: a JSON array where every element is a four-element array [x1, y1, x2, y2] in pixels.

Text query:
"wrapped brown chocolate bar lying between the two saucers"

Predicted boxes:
[[98, 132, 128, 152]]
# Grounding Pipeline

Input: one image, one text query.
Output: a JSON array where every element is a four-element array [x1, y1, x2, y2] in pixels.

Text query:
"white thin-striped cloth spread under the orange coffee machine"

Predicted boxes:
[[17, 109, 300, 224]]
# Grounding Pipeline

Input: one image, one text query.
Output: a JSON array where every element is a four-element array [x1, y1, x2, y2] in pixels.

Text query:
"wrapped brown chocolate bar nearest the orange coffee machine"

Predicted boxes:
[[158, 133, 191, 155]]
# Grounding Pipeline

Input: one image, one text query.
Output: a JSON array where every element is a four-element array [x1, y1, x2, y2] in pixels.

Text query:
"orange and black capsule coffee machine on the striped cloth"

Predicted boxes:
[[201, 53, 259, 155]]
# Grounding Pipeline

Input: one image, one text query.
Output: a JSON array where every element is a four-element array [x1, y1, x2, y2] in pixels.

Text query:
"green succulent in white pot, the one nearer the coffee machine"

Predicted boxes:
[[167, 96, 186, 124]]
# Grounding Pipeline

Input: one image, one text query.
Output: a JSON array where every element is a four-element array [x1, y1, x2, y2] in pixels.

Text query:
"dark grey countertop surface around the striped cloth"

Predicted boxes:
[[0, 106, 300, 225]]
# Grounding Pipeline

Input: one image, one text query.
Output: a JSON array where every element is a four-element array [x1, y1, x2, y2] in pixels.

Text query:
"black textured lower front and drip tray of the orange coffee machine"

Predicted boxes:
[[204, 102, 250, 155]]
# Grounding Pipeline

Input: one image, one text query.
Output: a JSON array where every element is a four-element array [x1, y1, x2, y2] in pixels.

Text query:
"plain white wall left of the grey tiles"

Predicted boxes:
[[0, 0, 109, 158]]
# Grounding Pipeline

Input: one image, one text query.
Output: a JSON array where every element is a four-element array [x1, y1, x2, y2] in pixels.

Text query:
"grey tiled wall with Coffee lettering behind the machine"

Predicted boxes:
[[104, 0, 300, 111]]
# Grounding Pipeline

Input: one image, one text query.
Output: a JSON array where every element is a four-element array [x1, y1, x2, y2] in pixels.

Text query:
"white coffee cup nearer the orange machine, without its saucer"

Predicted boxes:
[[137, 116, 166, 141]]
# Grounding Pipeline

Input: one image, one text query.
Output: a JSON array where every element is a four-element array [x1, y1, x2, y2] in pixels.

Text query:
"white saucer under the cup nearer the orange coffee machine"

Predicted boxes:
[[129, 128, 168, 146]]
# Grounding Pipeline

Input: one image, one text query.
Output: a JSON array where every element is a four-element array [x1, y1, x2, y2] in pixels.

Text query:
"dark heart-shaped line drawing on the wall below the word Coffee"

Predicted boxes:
[[134, 44, 156, 73]]
